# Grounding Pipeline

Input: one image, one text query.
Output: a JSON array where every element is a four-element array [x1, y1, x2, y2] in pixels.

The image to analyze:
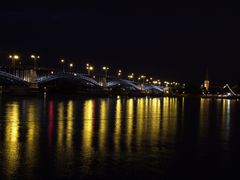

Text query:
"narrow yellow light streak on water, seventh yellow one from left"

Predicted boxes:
[[114, 99, 122, 153]]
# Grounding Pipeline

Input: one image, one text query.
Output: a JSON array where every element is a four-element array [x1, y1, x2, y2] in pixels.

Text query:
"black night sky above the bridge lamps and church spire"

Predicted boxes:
[[0, 2, 240, 83]]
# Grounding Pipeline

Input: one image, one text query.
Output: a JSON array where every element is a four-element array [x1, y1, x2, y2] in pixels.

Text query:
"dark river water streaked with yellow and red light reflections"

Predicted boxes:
[[0, 97, 240, 179]]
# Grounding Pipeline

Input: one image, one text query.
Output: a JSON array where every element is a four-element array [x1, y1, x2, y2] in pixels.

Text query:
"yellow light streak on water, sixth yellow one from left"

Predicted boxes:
[[99, 99, 109, 153]]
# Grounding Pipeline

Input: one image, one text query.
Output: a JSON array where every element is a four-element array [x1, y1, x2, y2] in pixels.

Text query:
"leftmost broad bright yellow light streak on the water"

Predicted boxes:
[[4, 102, 19, 177]]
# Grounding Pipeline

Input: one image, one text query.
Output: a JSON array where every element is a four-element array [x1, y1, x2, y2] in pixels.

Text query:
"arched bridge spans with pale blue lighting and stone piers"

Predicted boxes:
[[0, 71, 164, 93]]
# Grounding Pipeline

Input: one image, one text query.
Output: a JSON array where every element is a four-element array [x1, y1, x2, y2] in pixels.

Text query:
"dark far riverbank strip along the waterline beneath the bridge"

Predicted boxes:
[[0, 87, 240, 99]]
